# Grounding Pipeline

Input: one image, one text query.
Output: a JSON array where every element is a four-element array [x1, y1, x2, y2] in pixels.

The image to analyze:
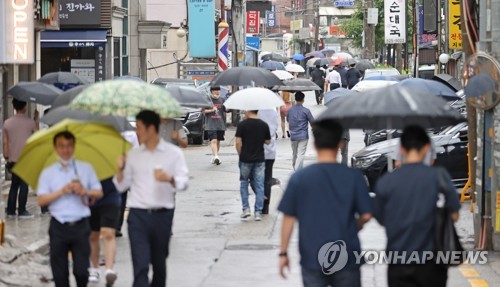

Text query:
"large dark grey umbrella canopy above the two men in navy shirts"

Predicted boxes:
[[318, 85, 465, 129]]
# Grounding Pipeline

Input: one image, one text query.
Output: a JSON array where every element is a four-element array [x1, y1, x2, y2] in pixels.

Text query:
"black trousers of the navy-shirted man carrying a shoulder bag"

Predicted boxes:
[[387, 263, 448, 287]]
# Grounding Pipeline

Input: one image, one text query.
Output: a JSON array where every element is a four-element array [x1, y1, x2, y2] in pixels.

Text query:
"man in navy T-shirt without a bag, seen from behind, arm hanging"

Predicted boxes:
[[278, 120, 371, 287]]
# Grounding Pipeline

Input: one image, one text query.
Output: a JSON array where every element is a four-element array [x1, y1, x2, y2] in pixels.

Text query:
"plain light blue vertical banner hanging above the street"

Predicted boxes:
[[188, 0, 216, 58]]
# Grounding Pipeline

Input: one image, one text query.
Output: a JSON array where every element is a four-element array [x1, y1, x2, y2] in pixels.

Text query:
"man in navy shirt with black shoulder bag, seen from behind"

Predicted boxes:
[[375, 126, 460, 287]]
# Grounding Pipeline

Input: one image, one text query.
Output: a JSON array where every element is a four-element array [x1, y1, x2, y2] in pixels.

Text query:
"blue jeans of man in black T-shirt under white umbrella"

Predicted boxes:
[[239, 161, 266, 212]]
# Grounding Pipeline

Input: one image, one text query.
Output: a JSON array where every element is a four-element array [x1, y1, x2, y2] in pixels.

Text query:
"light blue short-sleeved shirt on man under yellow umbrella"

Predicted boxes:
[[37, 160, 102, 223]]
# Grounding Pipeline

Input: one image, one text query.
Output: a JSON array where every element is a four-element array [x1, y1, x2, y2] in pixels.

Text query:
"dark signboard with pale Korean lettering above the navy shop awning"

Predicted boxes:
[[59, 0, 101, 27]]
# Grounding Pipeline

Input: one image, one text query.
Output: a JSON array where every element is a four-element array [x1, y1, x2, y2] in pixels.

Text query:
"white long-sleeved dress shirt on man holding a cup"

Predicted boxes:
[[113, 139, 189, 209]]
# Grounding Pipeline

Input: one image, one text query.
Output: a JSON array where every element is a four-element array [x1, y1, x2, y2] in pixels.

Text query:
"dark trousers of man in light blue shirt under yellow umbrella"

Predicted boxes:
[[49, 218, 90, 287]]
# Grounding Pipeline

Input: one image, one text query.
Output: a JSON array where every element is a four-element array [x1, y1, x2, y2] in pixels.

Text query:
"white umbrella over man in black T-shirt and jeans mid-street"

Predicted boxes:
[[224, 88, 285, 111]]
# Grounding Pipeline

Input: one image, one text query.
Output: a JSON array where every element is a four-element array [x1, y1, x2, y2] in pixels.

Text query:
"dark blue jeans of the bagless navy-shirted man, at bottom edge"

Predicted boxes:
[[302, 268, 361, 287]]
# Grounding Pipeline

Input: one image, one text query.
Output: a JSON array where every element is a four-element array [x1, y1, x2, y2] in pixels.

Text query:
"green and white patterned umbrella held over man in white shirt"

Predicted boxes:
[[70, 80, 183, 118]]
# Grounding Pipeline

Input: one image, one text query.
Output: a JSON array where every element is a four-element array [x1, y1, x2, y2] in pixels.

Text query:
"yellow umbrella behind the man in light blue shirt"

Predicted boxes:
[[12, 119, 131, 189]]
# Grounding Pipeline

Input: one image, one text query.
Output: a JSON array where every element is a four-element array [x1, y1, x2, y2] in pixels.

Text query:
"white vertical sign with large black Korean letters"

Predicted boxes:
[[384, 0, 406, 44]]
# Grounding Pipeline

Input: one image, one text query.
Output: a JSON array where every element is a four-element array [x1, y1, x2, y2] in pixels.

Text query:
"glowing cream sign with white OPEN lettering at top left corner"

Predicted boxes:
[[0, 0, 35, 64]]
